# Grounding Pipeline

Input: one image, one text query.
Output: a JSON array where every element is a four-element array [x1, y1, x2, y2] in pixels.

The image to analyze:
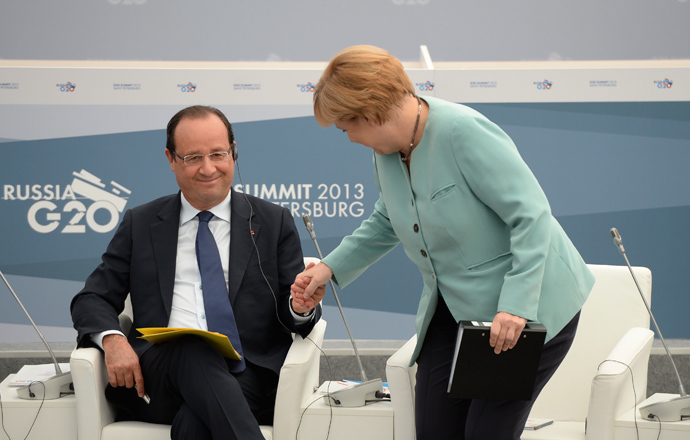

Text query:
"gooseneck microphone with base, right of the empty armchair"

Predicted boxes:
[[611, 228, 690, 422]]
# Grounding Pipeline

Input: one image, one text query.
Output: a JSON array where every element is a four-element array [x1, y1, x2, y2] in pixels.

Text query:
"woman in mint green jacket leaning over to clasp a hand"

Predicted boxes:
[[293, 46, 594, 440]]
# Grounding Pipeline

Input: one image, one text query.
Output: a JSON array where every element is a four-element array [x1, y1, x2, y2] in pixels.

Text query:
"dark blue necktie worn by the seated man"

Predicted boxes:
[[196, 211, 245, 373]]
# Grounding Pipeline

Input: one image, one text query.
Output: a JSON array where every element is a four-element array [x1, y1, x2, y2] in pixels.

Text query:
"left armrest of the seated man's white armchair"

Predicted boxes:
[[70, 348, 115, 439]]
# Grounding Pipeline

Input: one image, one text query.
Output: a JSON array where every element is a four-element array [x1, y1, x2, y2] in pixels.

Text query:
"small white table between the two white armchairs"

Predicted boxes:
[[297, 385, 393, 440]]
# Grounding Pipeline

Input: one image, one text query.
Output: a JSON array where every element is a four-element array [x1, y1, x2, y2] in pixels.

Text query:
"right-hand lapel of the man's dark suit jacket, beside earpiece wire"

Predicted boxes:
[[228, 190, 260, 304]]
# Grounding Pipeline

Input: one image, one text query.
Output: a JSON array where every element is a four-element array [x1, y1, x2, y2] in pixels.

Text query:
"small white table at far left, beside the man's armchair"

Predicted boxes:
[[0, 374, 77, 440]]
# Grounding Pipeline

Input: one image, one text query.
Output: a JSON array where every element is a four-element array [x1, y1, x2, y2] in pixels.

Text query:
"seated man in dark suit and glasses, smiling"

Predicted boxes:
[[71, 106, 325, 440]]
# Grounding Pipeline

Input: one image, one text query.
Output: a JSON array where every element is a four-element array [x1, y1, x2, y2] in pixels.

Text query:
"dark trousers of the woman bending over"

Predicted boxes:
[[415, 295, 580, 440]]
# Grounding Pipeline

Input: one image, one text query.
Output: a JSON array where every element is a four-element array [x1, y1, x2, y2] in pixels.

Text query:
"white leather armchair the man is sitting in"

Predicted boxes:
[[70, 258, 326, 440]]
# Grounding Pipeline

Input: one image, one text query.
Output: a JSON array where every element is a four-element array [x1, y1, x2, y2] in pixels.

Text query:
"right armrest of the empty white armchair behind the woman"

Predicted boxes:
[[586, 327, 654, 439]]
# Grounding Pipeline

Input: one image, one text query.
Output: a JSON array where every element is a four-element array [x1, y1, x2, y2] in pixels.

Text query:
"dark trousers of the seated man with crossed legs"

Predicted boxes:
[[106, 336, 278, 440]]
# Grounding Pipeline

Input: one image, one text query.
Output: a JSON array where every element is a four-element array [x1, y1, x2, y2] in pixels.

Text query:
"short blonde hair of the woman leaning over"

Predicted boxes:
[[314, 46, 414, 127]]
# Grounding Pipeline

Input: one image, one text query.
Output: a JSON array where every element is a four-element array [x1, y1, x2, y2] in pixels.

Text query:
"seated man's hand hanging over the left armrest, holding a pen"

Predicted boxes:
[[103, 334, 146, 398]]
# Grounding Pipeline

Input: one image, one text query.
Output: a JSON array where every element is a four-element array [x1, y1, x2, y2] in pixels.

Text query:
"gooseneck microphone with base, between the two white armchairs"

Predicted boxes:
[[302, 214, 383, 407]]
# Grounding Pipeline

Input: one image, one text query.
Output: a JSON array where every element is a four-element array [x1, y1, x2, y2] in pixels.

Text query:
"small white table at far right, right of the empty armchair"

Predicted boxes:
[[615, 393, 690, 440]]
